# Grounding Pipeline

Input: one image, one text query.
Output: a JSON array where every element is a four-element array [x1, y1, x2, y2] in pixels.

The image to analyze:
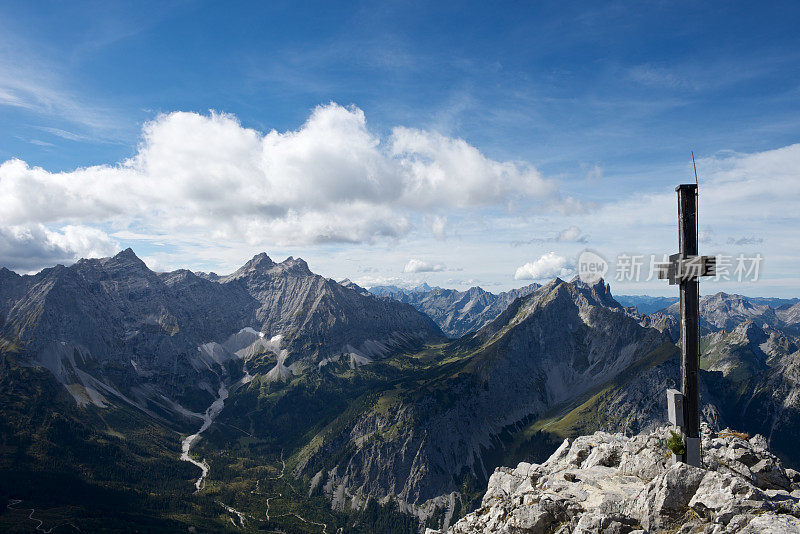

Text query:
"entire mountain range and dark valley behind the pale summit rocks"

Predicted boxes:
[[0, 249, 800, 532]]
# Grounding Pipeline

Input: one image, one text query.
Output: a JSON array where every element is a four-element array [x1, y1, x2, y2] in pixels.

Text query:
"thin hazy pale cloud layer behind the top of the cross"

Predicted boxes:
[[536, 144, 800, 295]]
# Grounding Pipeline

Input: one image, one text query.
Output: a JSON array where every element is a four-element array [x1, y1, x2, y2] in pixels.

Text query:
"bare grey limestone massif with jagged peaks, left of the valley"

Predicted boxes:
[[0, 249, 441, 369]]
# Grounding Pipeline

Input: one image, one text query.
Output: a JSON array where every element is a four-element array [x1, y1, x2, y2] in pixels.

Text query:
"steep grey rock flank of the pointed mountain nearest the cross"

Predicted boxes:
[[299, 279, 669, 520]]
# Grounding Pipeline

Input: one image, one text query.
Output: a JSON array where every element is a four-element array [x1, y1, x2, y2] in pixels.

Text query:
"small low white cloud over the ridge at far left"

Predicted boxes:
[[0, 224, 120, 272]]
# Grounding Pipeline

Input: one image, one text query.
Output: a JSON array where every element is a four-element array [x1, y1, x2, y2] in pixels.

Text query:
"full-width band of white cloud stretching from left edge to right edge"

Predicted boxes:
[[0, 100, 800, 294]]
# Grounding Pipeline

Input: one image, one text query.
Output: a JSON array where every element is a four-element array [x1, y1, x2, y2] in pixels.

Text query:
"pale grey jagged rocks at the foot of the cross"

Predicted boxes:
[[429, 425, 800, 534]]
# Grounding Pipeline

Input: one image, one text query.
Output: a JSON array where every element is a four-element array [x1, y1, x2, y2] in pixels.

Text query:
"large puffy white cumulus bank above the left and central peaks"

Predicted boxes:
[[0, 103, 557, 260]]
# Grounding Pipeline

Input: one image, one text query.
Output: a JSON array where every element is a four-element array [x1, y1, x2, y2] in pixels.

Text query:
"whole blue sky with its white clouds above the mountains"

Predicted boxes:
[[0, 2, 800, 296]]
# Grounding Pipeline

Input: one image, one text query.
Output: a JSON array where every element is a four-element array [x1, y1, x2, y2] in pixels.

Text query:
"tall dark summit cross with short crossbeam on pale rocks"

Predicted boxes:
[[658, 184, 716, 467]]
